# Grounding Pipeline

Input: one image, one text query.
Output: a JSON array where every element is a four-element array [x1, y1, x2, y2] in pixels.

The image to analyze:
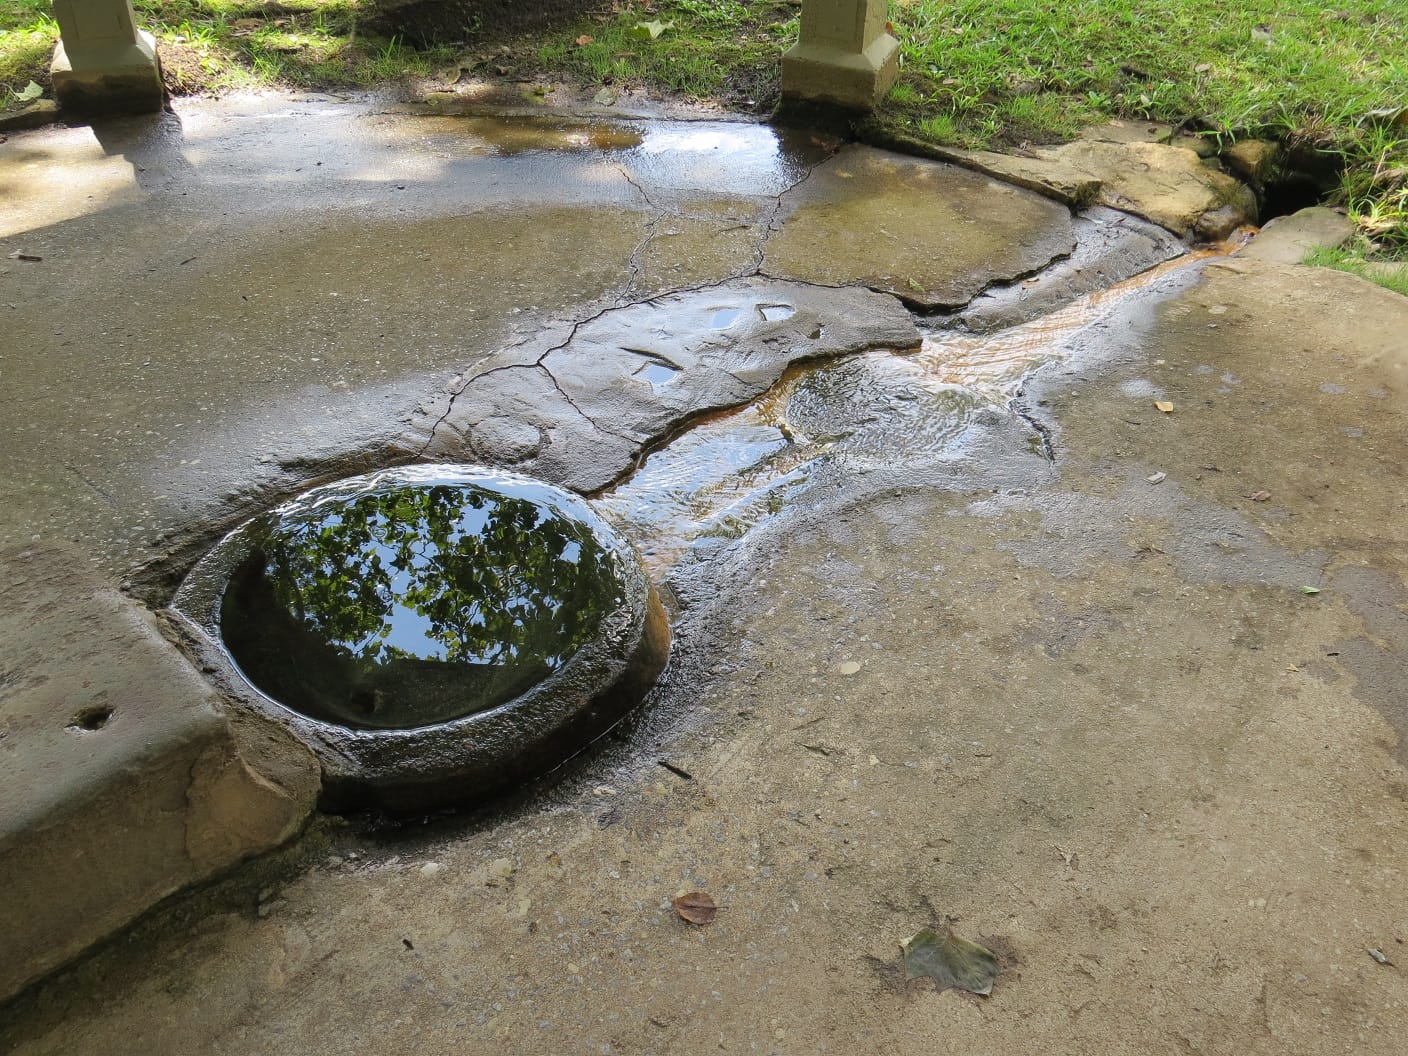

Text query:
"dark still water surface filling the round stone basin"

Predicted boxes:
[[221, 483, 621, 728]]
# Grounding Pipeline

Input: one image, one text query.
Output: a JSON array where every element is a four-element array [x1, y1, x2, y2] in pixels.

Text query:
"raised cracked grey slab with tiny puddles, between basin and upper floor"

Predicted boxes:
[[414, 279, 919, 491]]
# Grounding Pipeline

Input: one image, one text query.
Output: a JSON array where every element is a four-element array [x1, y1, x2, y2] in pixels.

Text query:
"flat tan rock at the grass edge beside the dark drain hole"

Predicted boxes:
[[945, 137, 1256, 241]]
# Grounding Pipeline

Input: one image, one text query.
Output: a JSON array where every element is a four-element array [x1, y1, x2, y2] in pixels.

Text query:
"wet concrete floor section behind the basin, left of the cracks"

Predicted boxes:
[[0, 105, 825, 574]]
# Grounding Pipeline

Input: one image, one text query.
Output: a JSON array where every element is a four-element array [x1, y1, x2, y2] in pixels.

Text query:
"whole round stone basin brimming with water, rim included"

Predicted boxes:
[[175, 466, 669, 808]]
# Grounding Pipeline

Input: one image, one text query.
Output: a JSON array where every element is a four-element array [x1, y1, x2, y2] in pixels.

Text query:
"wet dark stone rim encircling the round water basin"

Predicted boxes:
[[168, 463, 670, 812]]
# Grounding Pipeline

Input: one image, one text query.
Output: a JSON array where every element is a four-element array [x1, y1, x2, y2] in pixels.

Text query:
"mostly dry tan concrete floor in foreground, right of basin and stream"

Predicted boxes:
[[11, 260, 1408, 1056]]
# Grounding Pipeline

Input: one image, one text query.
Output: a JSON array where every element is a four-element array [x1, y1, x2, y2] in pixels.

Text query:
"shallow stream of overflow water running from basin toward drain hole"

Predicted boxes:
[[597, 251, 1217, 577]]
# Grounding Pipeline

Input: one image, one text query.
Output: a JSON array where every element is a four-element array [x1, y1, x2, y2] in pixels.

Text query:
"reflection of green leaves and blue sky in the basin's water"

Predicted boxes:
[[263, 486, 614, 670]]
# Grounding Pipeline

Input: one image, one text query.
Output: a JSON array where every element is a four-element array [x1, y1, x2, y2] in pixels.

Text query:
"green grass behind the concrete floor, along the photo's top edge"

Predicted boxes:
[[0, 0, 1408, 290]]
